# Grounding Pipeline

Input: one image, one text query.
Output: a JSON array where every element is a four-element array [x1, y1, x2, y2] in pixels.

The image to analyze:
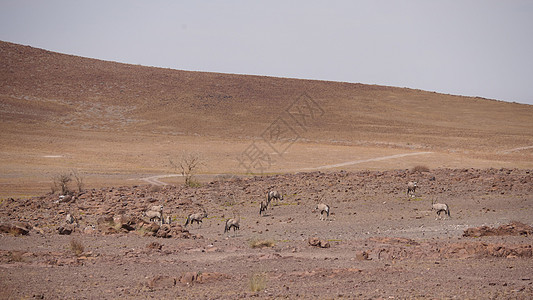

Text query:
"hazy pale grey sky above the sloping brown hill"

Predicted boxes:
[[0, 0, 533, 104]]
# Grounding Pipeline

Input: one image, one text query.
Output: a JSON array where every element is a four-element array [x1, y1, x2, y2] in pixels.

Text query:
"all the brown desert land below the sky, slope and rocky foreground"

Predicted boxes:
[[0, 42, 533, 299]]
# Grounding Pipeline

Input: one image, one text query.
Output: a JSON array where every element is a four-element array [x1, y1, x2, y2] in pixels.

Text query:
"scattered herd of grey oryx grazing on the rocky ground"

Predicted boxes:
[[144, 181, 451, 237]]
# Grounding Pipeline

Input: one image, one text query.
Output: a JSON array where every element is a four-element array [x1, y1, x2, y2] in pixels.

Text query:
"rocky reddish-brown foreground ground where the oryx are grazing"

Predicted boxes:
[[0, 168, 533, 299]]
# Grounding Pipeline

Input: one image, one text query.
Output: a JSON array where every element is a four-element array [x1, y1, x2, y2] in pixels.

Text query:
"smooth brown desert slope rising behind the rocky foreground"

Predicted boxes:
[[0, 42, 533, 196]]
